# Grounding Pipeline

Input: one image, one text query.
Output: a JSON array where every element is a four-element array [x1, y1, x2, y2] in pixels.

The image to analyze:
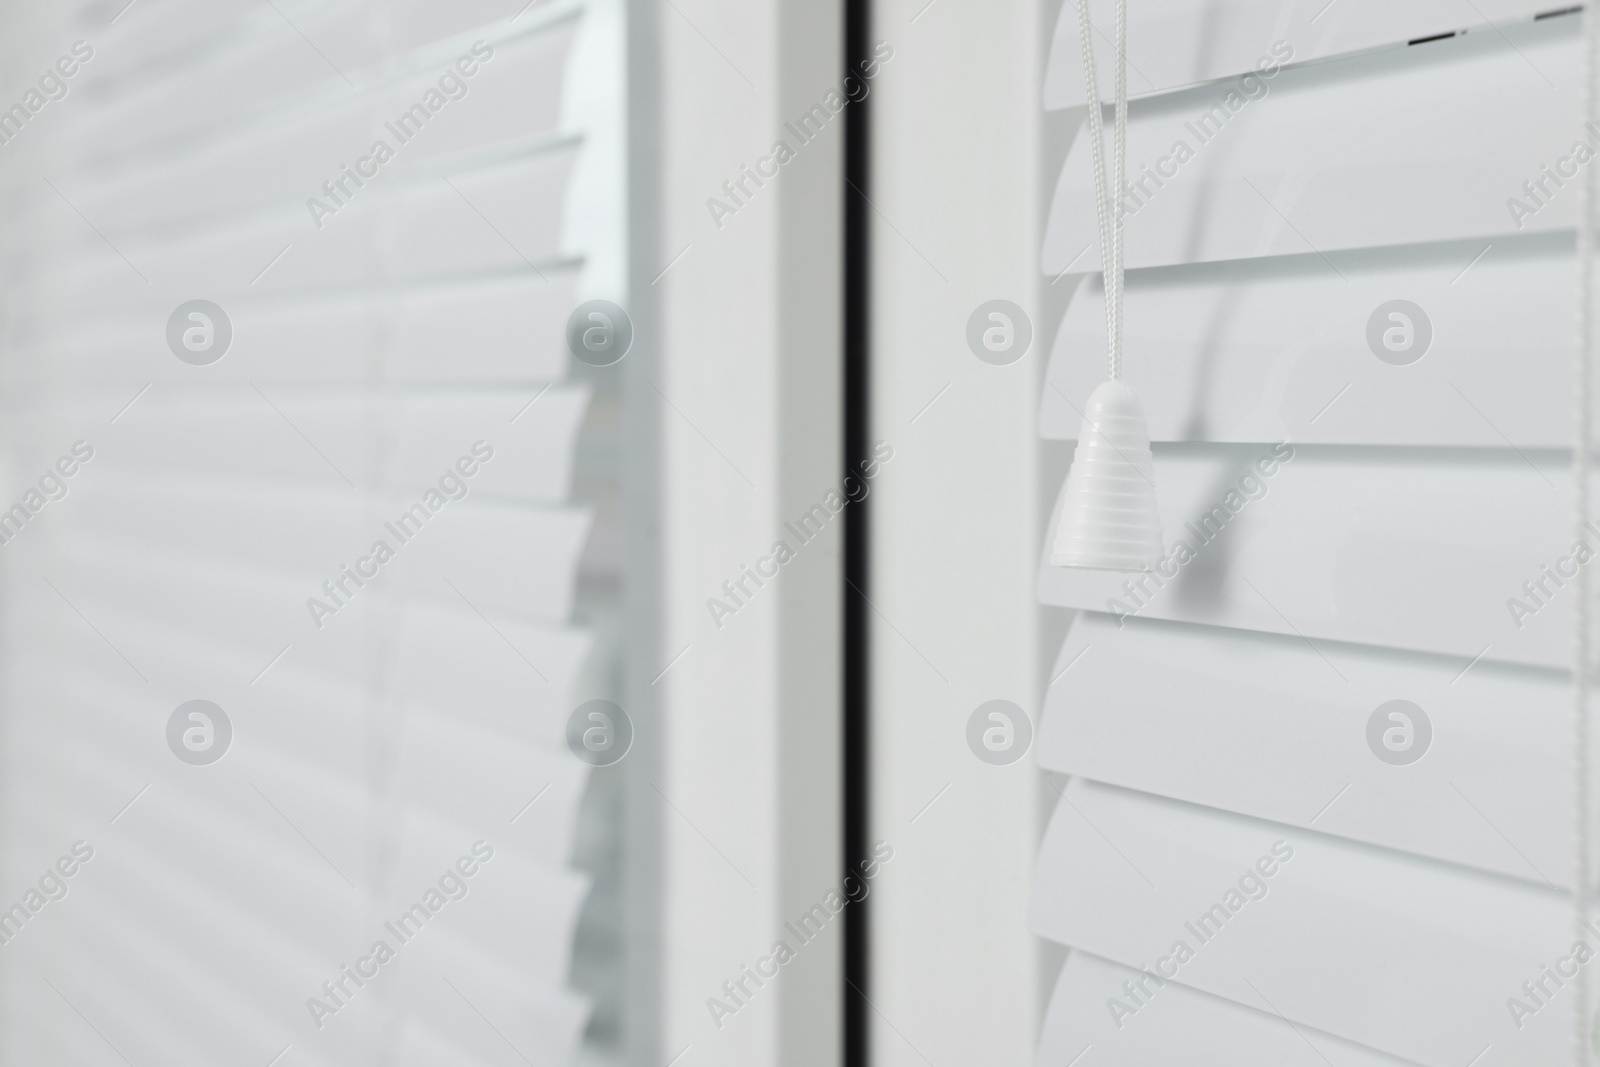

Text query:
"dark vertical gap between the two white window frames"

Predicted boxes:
[[840, 0, 872, 1067]]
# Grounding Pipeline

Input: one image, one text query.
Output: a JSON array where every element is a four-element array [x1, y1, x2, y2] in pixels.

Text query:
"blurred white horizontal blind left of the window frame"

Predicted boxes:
[[0, 0, 592, 1065]]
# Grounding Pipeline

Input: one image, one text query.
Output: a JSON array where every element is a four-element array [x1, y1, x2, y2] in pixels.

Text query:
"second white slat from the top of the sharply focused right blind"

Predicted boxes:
[[1043, 18, 1578, 274]]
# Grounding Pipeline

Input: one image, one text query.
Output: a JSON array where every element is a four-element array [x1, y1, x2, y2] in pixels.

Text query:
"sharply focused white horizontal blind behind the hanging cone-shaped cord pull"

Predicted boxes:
[[1034, 0, 1600, 1067]]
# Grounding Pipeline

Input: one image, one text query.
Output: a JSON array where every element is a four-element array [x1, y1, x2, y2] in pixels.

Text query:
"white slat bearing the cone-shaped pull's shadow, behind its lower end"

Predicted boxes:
[[1038, 445, 1574, 670]]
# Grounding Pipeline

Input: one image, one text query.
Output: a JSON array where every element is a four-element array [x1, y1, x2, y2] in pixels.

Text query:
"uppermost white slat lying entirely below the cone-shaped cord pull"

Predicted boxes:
[[1038, 613, 1580, 886]]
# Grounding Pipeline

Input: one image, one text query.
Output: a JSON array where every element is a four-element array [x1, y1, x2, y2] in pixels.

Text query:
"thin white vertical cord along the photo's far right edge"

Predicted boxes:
[[1573, 5, 1600, 1067]]
